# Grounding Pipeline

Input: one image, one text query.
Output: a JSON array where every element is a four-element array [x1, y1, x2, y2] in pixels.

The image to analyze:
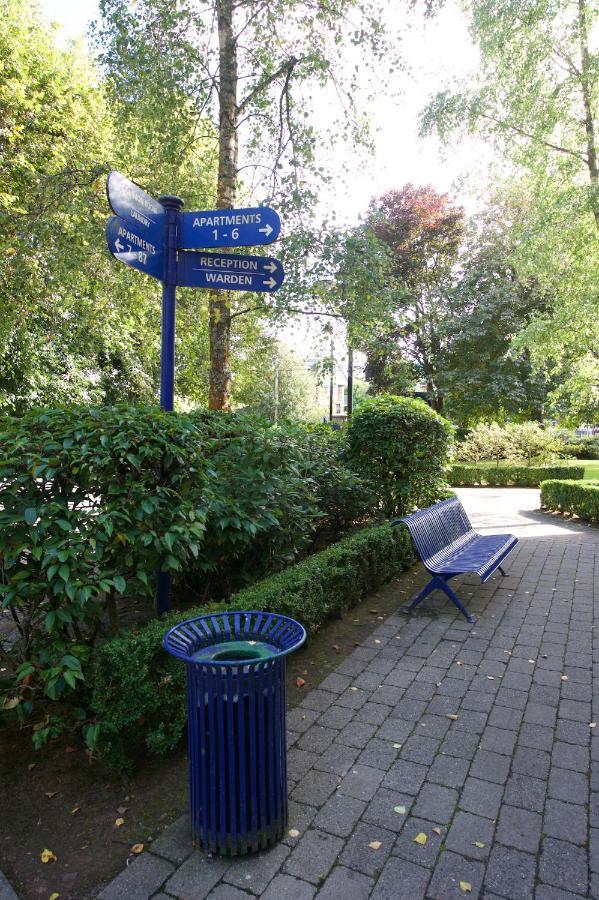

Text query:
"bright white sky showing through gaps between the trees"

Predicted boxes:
[[40, 0, 491, 366]]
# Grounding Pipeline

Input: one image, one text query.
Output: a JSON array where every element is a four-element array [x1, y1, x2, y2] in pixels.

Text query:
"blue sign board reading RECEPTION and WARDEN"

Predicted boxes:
[[177, 251, 285, 293]]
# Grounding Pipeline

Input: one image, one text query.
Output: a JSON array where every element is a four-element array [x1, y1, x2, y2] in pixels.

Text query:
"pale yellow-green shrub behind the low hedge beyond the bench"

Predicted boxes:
[[456, 422, 562, 464]]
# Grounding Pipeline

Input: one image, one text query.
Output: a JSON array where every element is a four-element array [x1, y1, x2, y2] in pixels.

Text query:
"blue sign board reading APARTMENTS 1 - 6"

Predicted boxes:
[[179, 206, 281, 250]]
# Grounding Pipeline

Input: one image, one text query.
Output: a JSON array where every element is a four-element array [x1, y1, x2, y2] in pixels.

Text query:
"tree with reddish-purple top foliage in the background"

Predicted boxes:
[[369, 184, 464, 411]]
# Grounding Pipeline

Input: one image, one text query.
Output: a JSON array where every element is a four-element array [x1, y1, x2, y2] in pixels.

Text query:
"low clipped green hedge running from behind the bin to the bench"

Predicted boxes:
[[91, 525, 414, 768]]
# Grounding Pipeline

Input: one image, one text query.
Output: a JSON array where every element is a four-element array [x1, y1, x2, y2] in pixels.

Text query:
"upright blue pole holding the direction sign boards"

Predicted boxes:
[[156, 194, 183, 615]]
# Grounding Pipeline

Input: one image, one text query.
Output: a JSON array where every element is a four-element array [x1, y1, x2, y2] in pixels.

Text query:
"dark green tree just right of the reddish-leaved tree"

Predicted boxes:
[[443, 198, 552, 425]]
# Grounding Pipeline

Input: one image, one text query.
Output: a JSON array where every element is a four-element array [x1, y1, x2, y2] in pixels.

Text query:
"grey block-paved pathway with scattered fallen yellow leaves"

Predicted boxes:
[[99, 489, 599, 900]]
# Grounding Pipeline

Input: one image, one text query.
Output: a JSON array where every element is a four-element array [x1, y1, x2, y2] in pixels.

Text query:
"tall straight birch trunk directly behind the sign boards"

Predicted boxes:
[[208, 0, 239, 410]]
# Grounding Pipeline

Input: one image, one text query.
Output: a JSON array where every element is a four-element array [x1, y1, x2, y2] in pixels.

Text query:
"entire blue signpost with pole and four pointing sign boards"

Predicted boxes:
[[106, 172, 285, 613]]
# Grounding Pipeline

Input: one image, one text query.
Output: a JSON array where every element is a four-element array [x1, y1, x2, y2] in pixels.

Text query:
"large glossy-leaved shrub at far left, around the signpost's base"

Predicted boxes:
[[0, 406, 207, 743]]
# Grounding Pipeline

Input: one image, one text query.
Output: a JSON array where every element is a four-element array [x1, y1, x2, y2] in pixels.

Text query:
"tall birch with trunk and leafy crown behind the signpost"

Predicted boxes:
[[100, 0, 393, 409]]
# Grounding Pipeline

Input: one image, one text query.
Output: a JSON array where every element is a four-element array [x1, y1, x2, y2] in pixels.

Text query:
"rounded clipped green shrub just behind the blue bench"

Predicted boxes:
[[347, 395, 452, 517]]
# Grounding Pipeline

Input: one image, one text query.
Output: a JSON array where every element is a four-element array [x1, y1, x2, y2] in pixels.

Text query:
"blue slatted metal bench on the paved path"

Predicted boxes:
[[391, 497, 518, 623]]
